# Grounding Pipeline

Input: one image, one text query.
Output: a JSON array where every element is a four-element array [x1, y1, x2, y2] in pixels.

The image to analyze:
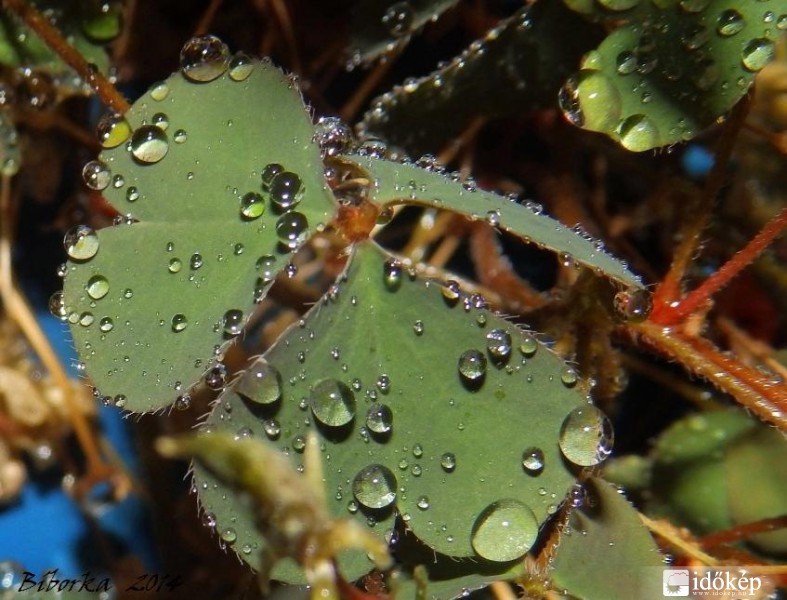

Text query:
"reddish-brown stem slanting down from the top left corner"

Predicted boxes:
[[3, 0, 130, 114]]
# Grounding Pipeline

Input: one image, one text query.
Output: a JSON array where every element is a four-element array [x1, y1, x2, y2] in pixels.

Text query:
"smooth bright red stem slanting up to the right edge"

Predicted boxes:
[[651, 208, 787, 325]]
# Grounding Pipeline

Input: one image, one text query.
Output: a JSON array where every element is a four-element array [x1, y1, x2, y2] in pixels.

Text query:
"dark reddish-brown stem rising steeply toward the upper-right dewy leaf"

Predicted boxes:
[[651, 96, 751, 319]]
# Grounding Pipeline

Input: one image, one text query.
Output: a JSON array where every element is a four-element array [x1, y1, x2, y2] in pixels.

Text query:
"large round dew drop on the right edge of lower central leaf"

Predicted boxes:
[[558, 404, 614, 467]]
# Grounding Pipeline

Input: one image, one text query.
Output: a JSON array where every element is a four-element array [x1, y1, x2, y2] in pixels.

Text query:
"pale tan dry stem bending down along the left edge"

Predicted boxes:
[[0, 175, 113, 490]]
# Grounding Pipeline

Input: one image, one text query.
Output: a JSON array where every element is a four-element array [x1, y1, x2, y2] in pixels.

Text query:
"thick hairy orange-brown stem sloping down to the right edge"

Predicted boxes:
[[628, 321, 787, 431]]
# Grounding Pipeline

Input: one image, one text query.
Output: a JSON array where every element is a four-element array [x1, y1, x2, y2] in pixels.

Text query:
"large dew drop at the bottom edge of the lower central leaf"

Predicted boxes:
[[470, 499, 538, 562]]
